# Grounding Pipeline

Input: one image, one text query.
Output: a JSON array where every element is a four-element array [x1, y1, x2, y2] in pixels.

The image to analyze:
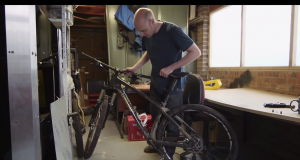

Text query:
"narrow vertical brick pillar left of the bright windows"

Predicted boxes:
[[197, 5, 209, 80]]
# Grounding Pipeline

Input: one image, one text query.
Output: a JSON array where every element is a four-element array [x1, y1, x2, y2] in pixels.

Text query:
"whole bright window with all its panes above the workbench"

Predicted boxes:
[[209, 5, 300, 67]]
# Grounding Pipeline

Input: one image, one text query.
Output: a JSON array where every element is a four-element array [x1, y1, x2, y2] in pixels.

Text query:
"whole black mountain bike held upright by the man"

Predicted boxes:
[[82, 53, 238, 160]]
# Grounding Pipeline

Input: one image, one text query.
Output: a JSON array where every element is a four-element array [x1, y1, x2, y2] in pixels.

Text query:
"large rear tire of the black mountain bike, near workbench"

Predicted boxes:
[[157, 104, 238, 160]]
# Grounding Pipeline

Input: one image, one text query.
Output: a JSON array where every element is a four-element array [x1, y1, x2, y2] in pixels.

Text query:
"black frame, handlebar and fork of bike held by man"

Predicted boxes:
[[83, 53, 196, 158]]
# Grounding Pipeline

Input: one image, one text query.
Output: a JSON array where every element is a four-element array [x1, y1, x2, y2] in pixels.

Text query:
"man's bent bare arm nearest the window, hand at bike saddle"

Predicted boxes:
[[159, 43, 201, 78]]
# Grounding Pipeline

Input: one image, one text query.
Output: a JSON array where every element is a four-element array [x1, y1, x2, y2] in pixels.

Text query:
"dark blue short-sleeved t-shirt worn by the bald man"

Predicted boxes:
[[142, 21, 194, 94]]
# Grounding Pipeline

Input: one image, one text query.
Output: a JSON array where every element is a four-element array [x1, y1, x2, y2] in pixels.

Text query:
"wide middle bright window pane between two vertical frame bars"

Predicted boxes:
[[244, 5, 292, 67]]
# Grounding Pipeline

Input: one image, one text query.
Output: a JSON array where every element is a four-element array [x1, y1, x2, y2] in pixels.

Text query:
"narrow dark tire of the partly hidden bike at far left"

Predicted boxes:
[[72, 99, 84, 158]]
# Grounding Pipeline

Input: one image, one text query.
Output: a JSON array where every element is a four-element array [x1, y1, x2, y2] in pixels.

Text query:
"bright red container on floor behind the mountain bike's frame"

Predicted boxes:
[[127, 114, 152, 141]]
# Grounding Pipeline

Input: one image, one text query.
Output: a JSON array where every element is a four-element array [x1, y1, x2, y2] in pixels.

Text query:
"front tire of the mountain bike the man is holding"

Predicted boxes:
[[84, 98, 108, 159]]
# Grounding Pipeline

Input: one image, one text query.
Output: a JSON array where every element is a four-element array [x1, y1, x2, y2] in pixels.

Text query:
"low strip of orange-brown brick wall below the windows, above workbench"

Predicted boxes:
[[209, 71, 300, 96]]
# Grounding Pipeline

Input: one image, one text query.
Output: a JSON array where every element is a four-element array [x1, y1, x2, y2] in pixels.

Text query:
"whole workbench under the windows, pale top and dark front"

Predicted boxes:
[[205, 88, 300, 160]]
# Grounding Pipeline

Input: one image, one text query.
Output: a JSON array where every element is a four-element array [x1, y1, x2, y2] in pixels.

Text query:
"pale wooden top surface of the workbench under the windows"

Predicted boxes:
[[205, 88, 300, 123]]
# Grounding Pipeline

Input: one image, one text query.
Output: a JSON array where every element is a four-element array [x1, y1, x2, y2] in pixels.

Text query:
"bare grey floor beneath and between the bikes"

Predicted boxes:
[[74, 115, 160, 160]]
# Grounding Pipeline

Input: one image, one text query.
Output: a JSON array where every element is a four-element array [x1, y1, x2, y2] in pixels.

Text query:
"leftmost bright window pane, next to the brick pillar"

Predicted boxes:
[[209, 5, 242, 67]]
